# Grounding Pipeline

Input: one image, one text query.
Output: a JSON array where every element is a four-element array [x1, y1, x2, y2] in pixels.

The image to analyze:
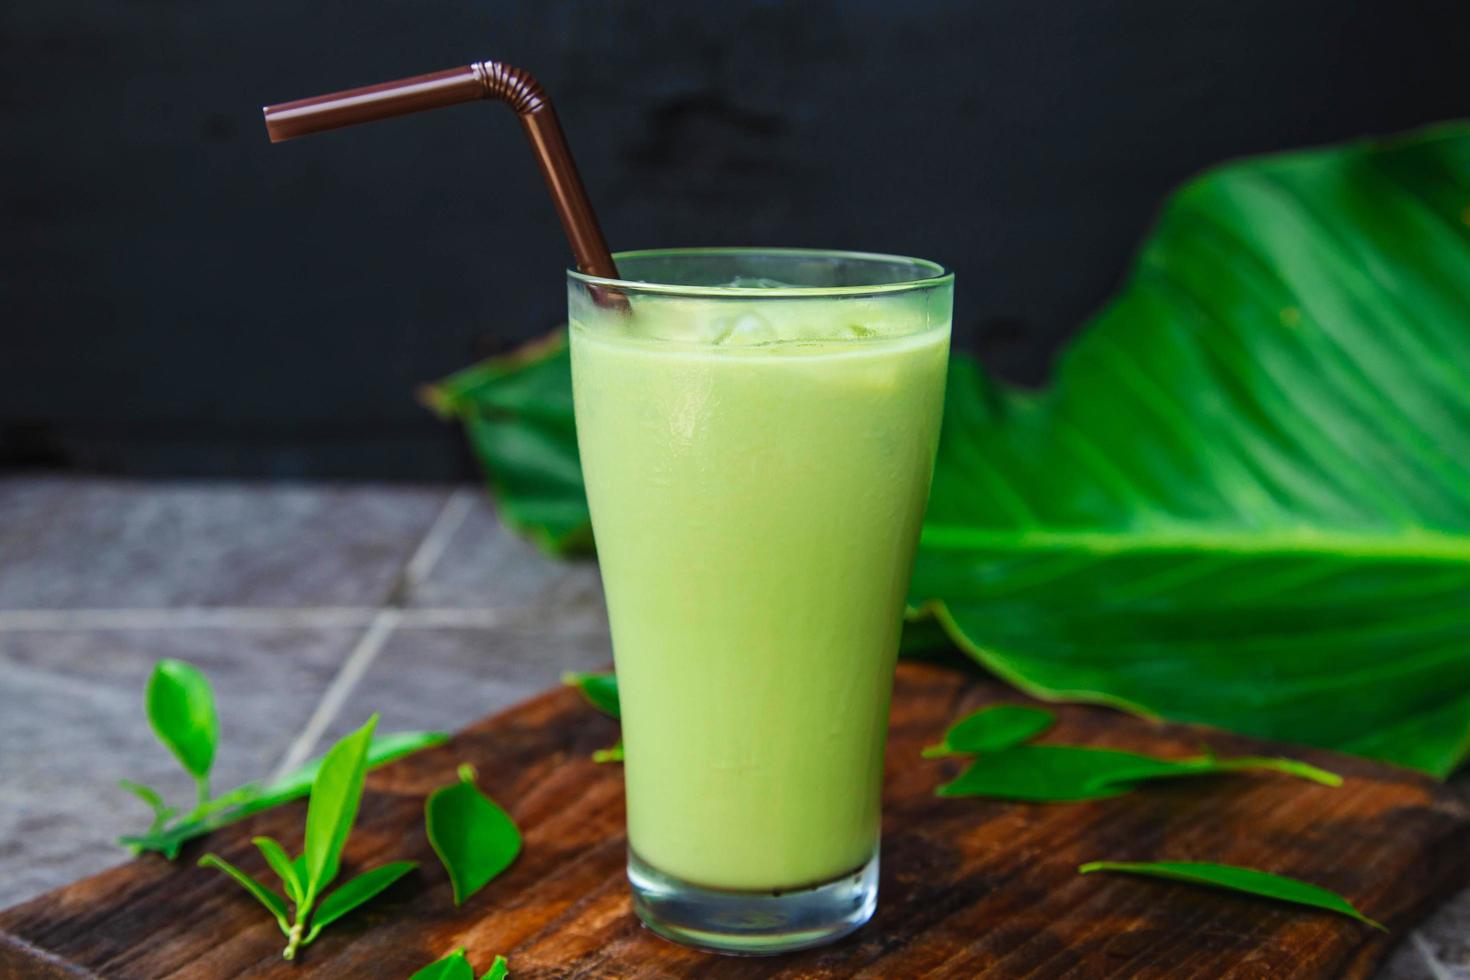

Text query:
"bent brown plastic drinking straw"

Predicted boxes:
[[265, 62, 617, 279]]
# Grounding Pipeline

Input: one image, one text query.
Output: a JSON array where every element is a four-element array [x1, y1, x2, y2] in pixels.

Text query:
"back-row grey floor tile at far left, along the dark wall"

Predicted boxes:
[[0, 478, 448, 610]]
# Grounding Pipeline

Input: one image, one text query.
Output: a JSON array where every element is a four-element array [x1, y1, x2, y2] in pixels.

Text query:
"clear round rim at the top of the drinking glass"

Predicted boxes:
[[566, 245, 954, 300]]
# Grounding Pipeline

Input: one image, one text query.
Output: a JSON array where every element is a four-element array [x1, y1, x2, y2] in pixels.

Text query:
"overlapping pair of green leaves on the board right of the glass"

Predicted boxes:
[[925, 705, 1342, 802]]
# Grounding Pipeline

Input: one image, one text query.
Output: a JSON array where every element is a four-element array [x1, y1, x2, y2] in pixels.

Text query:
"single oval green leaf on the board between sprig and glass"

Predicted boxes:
[[423, 765, 520, 905]]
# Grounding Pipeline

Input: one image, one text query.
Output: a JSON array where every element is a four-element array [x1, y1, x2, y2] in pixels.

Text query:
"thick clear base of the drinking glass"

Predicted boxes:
[[628, 849, 878, 956]]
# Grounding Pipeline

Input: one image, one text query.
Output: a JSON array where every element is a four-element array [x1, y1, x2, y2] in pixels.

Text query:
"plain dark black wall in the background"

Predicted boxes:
[[0, 0, 1470, 479]]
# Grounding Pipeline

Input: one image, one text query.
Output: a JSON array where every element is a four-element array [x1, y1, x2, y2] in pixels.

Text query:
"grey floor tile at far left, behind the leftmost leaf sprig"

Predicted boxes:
[[0, 629, 357, 907]]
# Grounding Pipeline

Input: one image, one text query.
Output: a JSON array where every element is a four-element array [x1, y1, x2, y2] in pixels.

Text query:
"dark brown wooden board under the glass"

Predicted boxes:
[[0, 663, 1470, 980]]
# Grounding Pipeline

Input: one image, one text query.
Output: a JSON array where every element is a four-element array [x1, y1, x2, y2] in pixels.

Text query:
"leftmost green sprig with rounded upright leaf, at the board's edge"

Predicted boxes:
[[118, 660, 448, 861]]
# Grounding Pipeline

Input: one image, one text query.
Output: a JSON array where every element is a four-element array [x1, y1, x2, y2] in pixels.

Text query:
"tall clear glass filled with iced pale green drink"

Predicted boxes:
[[569, 248, 954, 952]]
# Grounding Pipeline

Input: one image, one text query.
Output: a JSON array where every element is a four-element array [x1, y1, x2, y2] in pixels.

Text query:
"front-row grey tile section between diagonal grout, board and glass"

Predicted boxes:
[[325, 629, 613, 739]]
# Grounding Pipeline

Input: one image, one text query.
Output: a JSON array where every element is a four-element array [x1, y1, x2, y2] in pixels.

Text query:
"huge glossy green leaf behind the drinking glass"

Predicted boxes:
[[437, 123, 1470, 776]]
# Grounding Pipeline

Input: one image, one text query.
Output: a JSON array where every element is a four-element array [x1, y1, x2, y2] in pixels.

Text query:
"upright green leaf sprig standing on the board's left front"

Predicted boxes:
[[198, 714, 419, 959]]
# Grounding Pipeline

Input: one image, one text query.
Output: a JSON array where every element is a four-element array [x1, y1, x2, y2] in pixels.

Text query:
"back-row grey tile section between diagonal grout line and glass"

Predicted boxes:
[[409, 492, 603, 613]]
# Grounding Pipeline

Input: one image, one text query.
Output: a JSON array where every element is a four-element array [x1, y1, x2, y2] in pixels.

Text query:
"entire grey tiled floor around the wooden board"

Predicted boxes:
[[0, 476, 1470, 980]]
